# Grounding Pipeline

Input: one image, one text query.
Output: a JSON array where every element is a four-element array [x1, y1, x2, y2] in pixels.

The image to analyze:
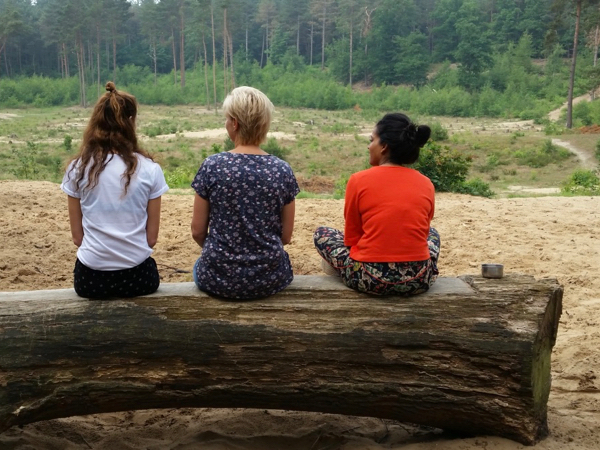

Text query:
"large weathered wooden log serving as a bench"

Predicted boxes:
[[0, 275, 562, 445]]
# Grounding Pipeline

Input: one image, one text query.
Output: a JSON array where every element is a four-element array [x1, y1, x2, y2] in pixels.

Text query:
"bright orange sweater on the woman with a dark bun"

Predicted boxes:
[[344, 166, 435, 262]]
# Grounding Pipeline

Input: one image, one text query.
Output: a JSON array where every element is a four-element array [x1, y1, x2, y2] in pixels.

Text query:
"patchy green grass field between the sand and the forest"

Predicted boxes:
[[0, 105, 600, 198]]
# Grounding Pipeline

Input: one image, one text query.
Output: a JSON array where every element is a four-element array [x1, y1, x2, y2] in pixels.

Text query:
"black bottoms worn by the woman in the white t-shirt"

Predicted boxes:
[[73, 258, 160, 299]]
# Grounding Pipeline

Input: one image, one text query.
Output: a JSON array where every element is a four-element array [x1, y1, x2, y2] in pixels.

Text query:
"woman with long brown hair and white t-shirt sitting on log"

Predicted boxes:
[[61, 82, 169, 298]]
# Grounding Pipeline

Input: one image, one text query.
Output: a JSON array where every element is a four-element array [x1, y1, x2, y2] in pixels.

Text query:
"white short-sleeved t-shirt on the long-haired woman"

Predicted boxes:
[[60, 155, 169, 270]]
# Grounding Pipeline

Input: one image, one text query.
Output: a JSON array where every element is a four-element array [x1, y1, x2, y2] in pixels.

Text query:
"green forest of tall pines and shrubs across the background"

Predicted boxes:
[[0, 0, 600, 123]]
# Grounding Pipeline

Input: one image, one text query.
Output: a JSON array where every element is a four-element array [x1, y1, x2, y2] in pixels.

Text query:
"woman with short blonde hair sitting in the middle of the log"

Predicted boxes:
[[192, 86, 299, 300]]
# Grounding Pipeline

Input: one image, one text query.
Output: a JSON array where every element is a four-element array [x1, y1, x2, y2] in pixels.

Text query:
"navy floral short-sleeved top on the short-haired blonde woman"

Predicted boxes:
[[192, 152, 300, 299]]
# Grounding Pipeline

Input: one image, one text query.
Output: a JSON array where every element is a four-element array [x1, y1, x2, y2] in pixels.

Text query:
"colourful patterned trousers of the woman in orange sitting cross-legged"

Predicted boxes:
[[313, 227, 440, 295]]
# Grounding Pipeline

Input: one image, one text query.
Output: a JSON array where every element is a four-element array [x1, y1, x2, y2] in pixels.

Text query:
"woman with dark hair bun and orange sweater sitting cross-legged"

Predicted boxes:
[[314, 113, 440, 295]]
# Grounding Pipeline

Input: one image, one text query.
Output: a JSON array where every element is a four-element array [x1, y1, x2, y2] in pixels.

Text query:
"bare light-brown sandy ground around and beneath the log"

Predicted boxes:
[[0, 181, 600, 450]]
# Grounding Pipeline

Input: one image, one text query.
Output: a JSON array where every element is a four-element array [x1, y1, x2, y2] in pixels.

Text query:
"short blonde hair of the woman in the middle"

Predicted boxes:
[[223, 86, 275, 145]]
